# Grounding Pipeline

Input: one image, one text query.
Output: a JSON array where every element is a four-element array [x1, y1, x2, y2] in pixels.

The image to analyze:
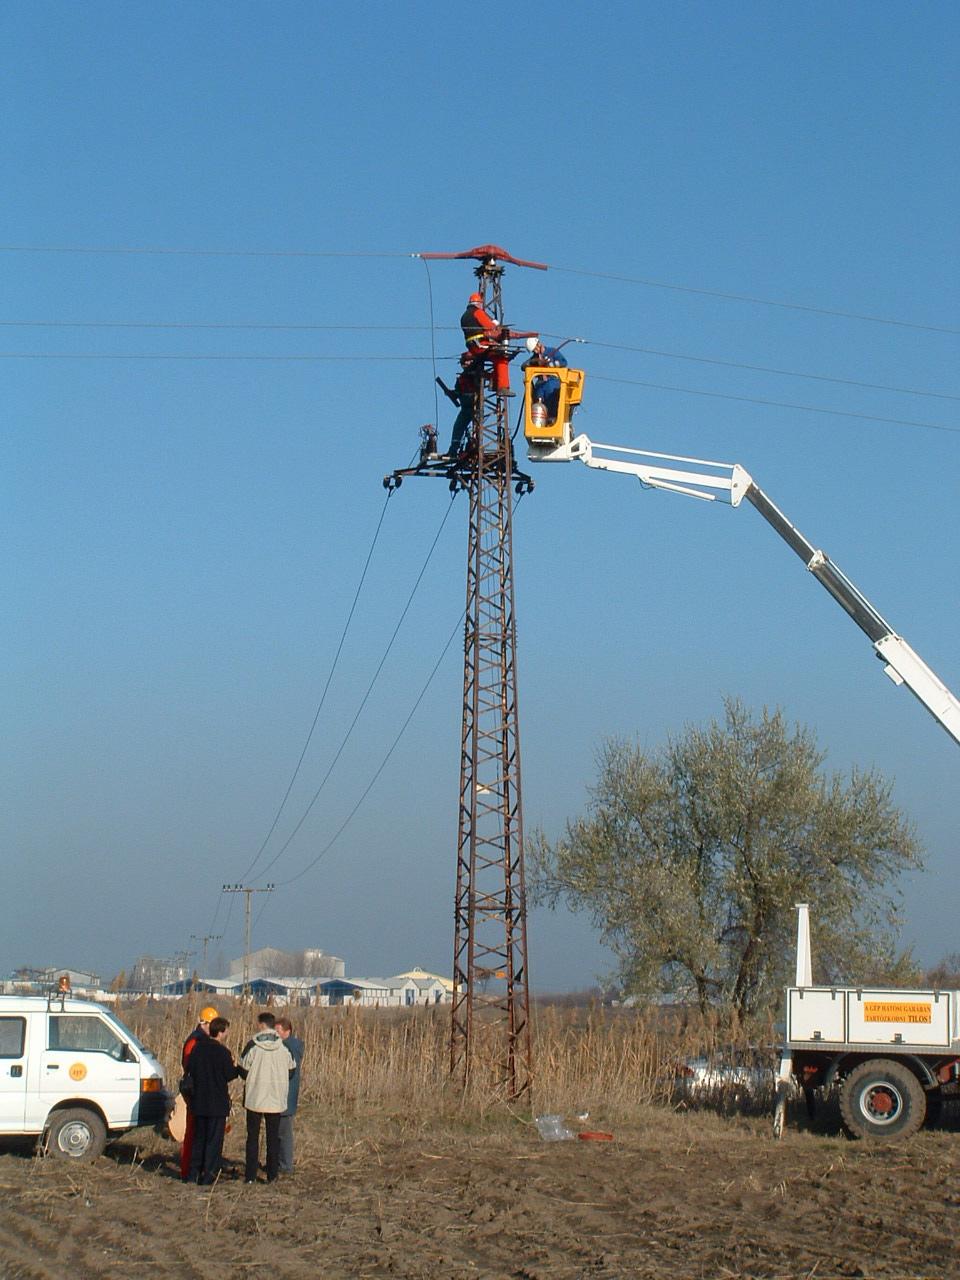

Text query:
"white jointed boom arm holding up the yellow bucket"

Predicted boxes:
[[529, 435, 960, 742]]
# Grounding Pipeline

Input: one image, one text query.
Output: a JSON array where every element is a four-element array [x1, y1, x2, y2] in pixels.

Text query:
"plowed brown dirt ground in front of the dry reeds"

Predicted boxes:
[[0, 1108, 960, 1280]]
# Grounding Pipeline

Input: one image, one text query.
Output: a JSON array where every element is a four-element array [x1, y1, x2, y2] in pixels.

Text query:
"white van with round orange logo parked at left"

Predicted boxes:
[[0, 993, 172, 1160]]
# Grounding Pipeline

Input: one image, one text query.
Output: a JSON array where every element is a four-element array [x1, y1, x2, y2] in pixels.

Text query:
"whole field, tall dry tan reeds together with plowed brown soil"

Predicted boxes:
[[0, 1001, 960, 1280]]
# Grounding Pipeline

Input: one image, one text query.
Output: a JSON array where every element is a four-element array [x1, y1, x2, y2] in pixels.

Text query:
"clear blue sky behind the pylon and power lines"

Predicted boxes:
[[0, 0, 960, 989]]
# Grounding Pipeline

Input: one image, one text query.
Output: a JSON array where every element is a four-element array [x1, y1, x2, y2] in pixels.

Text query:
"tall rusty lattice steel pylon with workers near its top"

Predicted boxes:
[[384, 244, 545, 1098]]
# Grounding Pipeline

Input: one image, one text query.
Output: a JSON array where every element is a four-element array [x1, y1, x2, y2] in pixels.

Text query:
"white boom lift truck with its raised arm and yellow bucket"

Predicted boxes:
[[524, 355, 960, 1140]]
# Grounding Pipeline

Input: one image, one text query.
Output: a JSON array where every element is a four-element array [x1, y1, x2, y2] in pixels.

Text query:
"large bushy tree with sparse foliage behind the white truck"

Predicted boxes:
[[531, 699, 920, 1016]]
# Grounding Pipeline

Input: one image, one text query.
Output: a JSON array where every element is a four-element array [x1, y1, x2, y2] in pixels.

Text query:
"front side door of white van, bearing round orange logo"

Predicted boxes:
[[40, 1010, 140, 1129]]
